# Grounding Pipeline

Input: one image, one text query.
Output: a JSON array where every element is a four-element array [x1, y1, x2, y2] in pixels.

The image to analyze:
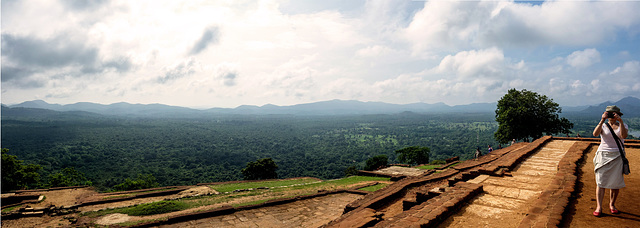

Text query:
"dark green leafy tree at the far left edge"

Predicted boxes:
[[2, 148, 42, 192]]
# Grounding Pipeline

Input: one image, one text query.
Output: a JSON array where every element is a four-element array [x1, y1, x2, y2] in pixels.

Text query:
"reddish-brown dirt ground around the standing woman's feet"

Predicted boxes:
[[562, 146, 640, 227]]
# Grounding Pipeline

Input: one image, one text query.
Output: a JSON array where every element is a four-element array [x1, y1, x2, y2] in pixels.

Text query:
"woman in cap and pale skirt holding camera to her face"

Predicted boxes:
[[593, 105, 629, 217]]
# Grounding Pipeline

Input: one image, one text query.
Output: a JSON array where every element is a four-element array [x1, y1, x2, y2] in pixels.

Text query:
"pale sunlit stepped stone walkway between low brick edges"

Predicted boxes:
[[442, 140, 573, 227]]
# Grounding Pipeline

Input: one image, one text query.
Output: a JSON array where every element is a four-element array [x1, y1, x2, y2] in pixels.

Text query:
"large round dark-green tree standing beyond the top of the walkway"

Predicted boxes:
[[494, 89, 573, 143]]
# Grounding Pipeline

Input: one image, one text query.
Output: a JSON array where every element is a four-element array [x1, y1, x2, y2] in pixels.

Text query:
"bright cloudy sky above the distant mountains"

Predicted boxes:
[[1, 0, 640, 108]]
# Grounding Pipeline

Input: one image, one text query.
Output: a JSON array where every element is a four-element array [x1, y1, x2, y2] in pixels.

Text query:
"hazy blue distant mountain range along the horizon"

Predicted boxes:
[[2, 97, 640, 117]]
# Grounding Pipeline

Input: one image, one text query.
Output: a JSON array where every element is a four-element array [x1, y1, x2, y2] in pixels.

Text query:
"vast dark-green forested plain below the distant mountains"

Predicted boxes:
[[2, 100, 640, 191]]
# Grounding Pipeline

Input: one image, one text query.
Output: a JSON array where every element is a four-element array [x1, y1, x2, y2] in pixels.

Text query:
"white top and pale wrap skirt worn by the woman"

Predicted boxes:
[[593, 124, 628, 189]]
